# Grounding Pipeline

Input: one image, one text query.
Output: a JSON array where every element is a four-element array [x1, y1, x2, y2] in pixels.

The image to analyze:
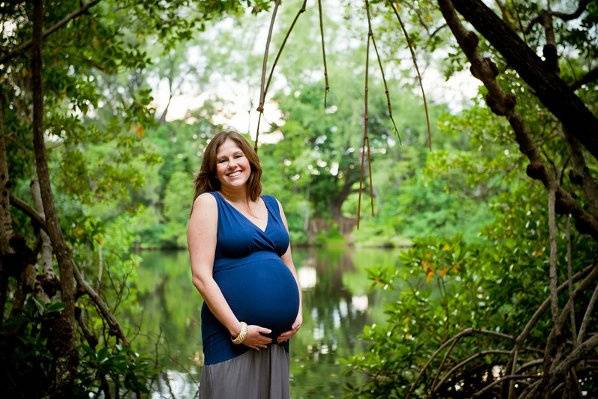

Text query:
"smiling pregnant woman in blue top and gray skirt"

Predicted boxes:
[[187, 131, 303, 399]]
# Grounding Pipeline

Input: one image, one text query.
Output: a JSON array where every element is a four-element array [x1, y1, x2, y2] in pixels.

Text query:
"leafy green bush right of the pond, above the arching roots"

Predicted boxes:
[[344, 171, 598, 398]]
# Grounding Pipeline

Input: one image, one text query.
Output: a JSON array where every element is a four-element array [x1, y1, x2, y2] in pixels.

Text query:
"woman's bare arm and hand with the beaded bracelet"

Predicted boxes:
[[187, 193, 271, 349]]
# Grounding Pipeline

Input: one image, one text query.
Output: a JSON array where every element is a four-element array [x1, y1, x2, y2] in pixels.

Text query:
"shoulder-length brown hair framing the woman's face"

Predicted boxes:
[[191, 130, 262, 208]]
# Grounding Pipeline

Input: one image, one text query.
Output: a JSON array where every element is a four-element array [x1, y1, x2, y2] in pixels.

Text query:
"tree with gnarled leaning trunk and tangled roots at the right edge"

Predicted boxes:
[[340, 0, 598, 397]]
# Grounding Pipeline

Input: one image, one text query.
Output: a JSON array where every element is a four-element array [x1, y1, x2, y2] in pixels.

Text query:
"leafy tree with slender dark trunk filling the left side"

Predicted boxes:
[[0, 0, 240, 397]]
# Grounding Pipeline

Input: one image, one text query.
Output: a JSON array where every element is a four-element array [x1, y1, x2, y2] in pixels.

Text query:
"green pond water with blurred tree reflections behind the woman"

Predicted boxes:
[[132, 248, 398, 399]]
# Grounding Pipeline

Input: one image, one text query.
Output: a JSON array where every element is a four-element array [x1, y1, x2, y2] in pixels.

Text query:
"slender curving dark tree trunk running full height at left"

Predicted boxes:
[[31, 0, 77, 397]]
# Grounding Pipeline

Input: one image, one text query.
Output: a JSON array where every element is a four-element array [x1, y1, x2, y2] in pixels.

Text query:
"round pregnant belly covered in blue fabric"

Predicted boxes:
[[214, 256, 299, 336]]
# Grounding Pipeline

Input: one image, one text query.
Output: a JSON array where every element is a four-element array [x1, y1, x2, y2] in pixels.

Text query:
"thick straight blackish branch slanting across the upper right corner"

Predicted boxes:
[[452, 0, 598, 161]]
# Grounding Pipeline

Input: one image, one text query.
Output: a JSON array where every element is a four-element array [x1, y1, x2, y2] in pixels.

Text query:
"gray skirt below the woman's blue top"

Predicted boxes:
[[199, 344, 289, 399]]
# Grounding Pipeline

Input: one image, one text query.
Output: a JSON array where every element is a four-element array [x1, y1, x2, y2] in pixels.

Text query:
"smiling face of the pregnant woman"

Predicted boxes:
[[216, 139, 251, 189]]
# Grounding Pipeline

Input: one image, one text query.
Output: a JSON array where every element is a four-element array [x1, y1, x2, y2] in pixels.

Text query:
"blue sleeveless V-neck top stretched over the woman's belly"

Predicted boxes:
[[201, 191, 299, 366]]
